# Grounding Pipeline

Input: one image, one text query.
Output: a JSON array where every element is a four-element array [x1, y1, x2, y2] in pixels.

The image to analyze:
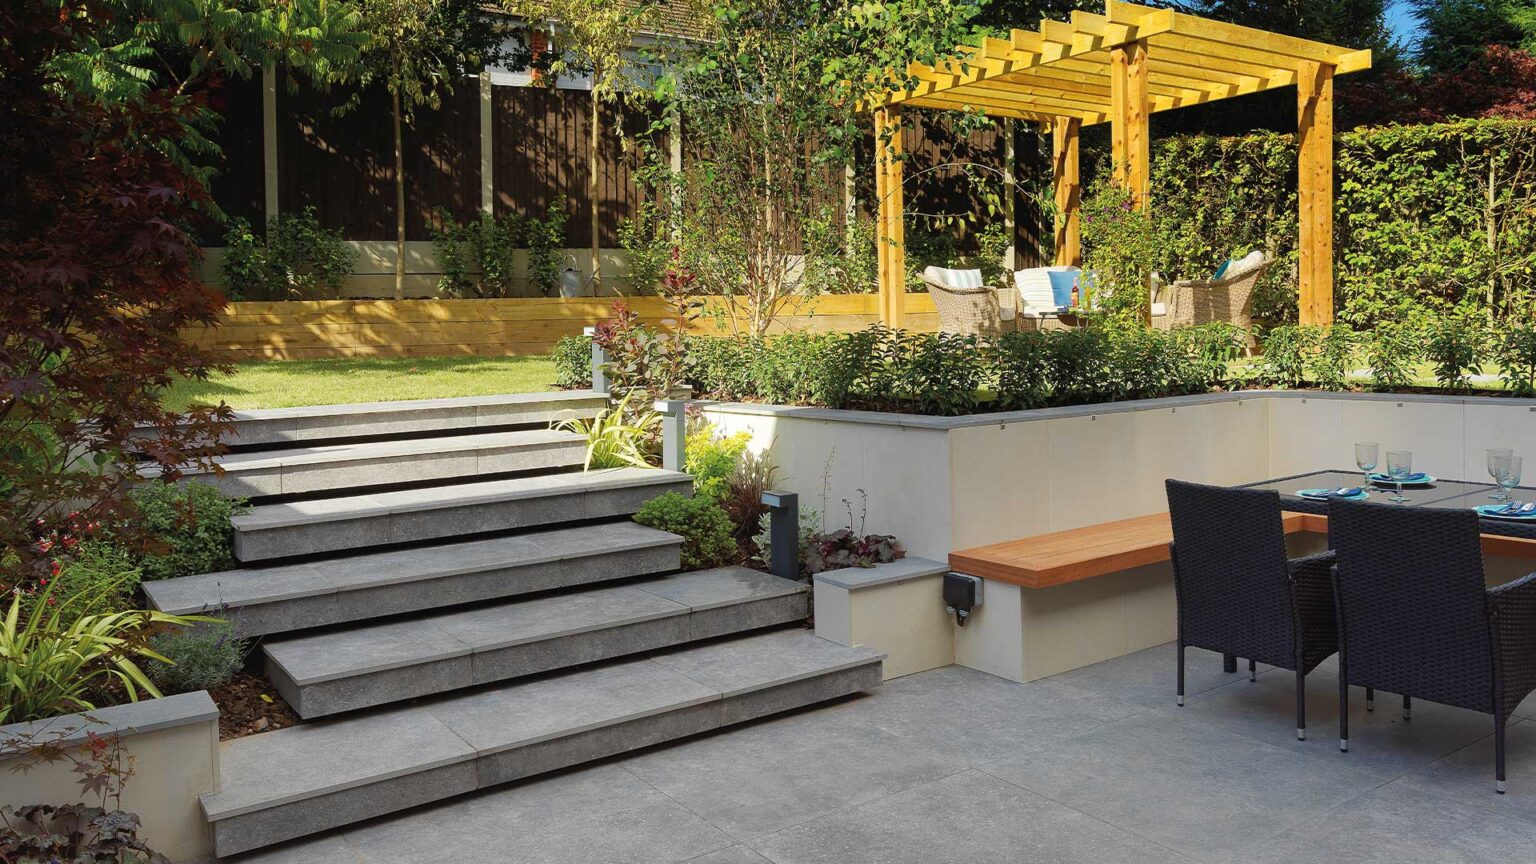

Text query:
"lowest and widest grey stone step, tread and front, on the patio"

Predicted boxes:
[[201, 629, 882, 856]]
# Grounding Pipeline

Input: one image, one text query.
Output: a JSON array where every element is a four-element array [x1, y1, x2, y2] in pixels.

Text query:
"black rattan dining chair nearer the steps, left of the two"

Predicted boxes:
[[1167, 480, 1338, 739]]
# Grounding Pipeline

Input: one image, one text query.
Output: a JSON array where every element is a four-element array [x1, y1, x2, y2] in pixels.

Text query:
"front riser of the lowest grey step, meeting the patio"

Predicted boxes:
[[212, 660, 880, 858]]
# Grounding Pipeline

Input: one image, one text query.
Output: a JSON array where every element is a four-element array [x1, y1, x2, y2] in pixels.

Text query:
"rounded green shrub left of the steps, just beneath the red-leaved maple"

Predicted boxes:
[[131, 480, 246, 581]]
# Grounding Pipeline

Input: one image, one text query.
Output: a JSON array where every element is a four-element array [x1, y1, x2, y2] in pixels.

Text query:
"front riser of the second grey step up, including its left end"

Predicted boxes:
[[266, 593, 808, 719]]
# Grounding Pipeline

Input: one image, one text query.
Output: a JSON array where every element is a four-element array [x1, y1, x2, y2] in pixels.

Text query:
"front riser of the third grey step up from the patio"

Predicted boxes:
[[187, 544, 682, 636]]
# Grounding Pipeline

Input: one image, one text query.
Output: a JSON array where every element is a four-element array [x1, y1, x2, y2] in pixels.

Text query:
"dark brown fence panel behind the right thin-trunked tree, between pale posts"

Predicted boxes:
[[492, 86, 668, 248]]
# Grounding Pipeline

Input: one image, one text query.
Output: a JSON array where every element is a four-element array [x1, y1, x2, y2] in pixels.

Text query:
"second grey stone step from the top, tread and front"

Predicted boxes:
[[162, 429, 587, 498]]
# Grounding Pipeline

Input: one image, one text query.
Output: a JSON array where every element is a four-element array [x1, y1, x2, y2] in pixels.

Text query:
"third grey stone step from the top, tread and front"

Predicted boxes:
[[232, 467, 693, 561]]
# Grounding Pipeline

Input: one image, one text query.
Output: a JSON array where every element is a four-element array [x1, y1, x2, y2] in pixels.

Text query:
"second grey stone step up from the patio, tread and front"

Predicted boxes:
[[263, 567, 809, 719]]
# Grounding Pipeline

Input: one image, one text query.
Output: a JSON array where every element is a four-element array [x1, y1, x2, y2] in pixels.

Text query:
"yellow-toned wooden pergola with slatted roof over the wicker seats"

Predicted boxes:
[[865, 0, 1370, 326]]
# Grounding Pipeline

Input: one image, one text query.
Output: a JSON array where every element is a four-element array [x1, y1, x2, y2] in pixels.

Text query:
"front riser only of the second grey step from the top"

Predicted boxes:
[[184, 441, 587, 498]]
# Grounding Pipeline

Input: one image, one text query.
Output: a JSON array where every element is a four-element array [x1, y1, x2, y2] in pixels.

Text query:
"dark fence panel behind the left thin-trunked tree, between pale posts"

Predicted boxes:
[[278, 70, 479, 240]]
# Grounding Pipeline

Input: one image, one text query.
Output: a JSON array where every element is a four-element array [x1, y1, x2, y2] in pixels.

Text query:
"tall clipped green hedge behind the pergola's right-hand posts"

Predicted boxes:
[[1152, 120, 1536, 326]]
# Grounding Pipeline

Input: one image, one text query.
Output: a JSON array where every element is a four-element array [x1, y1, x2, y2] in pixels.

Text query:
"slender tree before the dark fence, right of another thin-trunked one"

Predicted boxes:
[[508, 0, 653, 289]]
